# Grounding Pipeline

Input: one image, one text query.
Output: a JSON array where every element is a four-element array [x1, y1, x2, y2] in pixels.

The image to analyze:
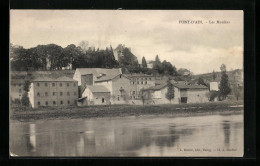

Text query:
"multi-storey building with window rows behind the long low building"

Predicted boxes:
[[126, 74, 155, 100]]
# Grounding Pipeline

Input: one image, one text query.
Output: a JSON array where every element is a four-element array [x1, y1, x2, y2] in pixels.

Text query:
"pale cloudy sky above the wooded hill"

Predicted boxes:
[[10, 10, 244, 74]]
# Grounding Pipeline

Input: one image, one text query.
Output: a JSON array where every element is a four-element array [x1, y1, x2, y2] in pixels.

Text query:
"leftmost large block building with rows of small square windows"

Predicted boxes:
[[28, 76, 78, 108]]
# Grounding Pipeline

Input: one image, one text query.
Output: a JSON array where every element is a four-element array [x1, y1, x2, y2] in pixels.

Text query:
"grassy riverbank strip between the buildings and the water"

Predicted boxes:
[[10, 102, 244, 121]]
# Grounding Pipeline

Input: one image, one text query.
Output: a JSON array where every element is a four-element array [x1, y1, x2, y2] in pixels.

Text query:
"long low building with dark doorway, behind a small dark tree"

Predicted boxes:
[[145, 82, 209, 104]]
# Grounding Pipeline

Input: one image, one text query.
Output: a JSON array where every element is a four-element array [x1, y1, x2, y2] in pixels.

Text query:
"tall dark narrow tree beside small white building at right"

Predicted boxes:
[[219, 64, 231, 99]]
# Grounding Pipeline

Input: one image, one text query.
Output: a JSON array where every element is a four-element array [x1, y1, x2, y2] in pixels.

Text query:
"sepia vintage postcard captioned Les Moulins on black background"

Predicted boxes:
[[9, 10, 244, 157]]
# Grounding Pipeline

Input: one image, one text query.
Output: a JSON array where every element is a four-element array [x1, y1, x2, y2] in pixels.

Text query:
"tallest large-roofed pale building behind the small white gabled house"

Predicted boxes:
[[73, 68, 122, 98]]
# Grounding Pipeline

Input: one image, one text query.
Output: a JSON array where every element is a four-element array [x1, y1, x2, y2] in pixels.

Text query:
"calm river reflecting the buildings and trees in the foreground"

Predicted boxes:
[[10, 114, 244, 157]]
